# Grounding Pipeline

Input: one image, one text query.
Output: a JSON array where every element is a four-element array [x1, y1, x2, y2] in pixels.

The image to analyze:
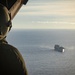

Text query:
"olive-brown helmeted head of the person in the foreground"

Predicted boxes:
[[0, 4, 12, 40]]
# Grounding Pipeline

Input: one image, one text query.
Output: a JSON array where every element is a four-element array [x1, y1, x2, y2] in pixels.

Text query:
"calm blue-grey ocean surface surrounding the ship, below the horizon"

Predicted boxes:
[[7, 29, 75, 75]]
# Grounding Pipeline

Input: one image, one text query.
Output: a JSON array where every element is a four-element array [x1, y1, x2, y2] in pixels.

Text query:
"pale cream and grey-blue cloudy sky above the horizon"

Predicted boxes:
[[12, 0, 75, 29]]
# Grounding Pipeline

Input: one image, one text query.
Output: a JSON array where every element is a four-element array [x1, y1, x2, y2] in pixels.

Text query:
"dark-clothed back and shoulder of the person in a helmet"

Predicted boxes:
[[0, 41, 27, 75]]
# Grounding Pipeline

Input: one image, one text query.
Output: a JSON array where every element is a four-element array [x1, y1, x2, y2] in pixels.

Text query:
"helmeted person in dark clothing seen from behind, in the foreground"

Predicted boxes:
[[0, 4, 27, 75]]
